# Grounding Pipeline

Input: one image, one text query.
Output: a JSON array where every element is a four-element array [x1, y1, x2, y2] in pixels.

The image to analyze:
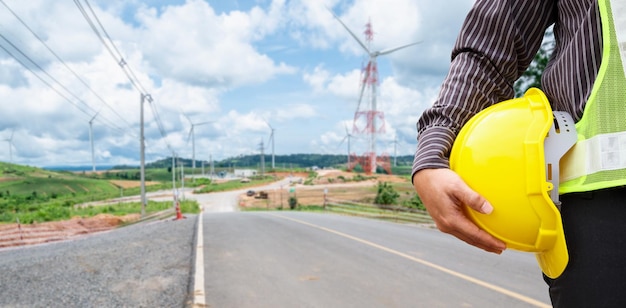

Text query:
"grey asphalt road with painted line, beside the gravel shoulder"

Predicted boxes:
[[190, 184, 550, 307]]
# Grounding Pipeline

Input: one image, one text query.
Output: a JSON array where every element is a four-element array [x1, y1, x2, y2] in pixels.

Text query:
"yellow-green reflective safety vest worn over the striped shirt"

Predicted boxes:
[[559, 0, 626, 194]]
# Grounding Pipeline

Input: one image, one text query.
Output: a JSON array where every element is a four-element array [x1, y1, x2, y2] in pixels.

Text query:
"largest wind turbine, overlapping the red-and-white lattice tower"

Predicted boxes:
[[327, 8, 420, 173]]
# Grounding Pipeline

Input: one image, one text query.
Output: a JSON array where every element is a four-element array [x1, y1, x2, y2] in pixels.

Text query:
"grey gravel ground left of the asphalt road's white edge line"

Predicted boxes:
[[0, 215, 197, 307]]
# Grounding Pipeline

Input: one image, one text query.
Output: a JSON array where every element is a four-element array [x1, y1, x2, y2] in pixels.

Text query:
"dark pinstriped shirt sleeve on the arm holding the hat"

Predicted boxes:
[[412, 0, 556, 179]]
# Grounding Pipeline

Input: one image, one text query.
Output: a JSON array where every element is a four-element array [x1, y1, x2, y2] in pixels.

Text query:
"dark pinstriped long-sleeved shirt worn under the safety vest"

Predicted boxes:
[[413, 0, 602, 174]]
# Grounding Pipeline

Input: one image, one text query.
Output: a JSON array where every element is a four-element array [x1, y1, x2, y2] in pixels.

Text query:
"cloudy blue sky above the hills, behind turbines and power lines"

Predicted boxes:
[[0, 0, 473, 166]]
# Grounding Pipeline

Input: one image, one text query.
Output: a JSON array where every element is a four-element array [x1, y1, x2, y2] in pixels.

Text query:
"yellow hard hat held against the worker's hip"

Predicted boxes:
[[450, 88, 577, 278]]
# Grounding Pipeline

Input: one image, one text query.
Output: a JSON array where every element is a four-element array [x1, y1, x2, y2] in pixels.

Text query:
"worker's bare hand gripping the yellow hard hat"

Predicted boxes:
[[413, 169, 506, 254]]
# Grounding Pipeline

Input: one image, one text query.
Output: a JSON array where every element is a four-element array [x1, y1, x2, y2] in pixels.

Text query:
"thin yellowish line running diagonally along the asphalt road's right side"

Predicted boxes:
[[271, 214, 552, 308]]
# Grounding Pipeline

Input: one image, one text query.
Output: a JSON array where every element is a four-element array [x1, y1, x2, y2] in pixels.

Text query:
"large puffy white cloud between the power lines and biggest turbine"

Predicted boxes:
[[137, 0, 294, 88]]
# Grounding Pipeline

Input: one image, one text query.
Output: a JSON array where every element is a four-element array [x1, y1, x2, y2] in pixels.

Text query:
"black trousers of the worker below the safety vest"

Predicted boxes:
[[544, 187, 626, 307]]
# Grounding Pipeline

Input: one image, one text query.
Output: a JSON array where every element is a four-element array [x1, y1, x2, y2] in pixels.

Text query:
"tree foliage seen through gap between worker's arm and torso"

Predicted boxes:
[[513, 28, 555, 97]]
